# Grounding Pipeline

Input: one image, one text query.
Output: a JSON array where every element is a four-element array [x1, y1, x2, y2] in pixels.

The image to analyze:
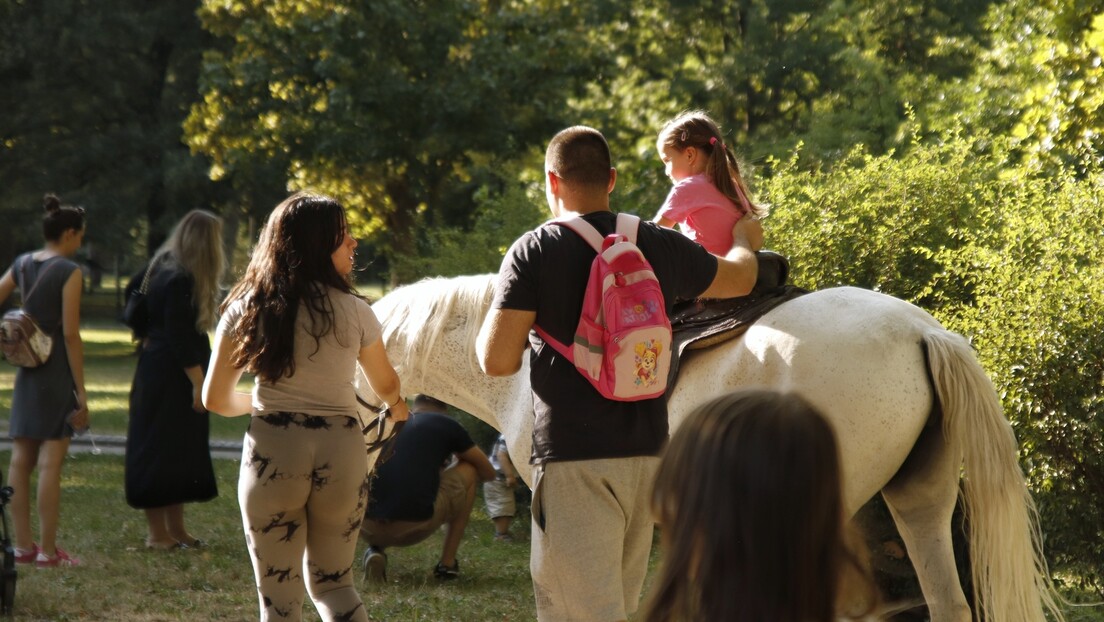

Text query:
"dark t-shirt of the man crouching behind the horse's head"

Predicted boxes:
[[368, 412, 475, 520]]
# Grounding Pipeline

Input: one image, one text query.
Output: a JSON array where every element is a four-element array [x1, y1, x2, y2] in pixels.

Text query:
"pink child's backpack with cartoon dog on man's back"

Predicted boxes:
[[534, 213, 671, 402]]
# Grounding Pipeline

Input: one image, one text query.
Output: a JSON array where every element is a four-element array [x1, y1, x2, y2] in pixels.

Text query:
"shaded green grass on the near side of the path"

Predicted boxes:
[[0, 452, 534, 622]]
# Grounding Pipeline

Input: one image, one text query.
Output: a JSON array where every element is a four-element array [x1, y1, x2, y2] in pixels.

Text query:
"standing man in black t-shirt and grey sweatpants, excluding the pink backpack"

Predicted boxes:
[[477, 126, 757, 622]]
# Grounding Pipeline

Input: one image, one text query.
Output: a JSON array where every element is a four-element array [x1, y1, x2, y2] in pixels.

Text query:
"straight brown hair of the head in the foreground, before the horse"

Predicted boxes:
[[644, 390, 877, 622]]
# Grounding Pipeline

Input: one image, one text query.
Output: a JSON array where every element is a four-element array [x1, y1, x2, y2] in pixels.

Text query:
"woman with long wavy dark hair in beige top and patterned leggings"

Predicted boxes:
[[203, 192, 410, 622]]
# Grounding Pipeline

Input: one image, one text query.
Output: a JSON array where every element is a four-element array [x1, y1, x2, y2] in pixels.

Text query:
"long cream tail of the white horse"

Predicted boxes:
[[924, 330, 1064, 622]]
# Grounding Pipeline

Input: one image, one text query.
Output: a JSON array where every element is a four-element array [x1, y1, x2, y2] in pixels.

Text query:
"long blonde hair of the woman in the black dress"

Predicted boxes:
[[149, 210, 226, 333]]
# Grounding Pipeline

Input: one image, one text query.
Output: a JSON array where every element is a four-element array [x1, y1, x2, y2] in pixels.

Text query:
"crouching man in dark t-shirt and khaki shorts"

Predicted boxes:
[[360, 394, 495, 581]]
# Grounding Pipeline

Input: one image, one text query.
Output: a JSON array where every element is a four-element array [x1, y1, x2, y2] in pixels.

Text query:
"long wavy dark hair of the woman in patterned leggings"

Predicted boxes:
[[222, 192, 357, 382]]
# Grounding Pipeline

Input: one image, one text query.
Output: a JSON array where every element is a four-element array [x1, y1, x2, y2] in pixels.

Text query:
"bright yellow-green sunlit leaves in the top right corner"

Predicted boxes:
[[922, 0, 1104, 172]]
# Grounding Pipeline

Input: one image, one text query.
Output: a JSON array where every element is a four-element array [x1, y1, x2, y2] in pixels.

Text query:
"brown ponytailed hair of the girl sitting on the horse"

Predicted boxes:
[[657, 110, 767, 218]]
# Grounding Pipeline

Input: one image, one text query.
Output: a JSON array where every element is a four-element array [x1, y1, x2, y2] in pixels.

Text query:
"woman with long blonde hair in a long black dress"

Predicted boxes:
[[126, 210, 225, 549]]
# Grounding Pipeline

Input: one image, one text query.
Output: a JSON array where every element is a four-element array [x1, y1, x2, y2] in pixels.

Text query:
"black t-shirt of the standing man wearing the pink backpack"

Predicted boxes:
[[491, 212, 716, 464]]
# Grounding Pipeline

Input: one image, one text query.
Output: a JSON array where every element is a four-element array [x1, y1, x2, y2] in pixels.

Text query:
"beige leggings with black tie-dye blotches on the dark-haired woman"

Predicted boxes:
[[237, 412, 368, 622]]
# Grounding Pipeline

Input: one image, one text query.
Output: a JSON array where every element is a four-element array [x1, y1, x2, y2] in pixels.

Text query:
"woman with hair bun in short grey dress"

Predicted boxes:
[[0, 194, 88, 568]]
